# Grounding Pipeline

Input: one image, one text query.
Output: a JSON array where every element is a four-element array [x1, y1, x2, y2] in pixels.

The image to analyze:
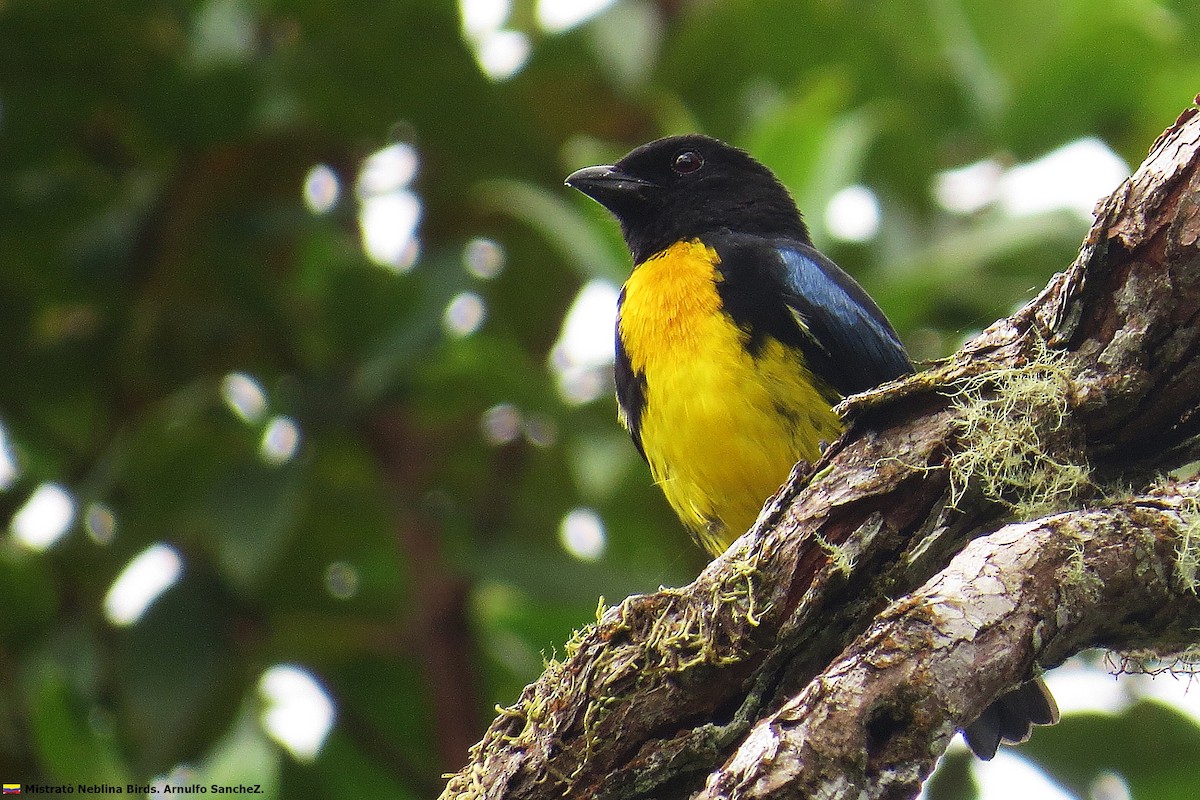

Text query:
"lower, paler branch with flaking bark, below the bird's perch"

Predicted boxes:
[[697, 483, 1200, 800]]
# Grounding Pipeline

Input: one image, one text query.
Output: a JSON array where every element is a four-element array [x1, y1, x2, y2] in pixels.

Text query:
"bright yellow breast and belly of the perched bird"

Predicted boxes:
[[618, 241, 841, 554]]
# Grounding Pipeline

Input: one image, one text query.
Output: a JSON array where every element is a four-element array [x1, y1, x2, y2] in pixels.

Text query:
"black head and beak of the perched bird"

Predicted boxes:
[[566, 133, 809, 264]]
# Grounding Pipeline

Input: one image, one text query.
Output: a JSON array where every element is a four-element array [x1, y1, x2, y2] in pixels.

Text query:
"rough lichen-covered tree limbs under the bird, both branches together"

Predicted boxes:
[[443, 100, 1200, 799]]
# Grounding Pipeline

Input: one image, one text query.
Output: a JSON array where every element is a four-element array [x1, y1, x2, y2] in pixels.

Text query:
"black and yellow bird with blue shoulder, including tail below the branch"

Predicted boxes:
[[565, 133, 1057, 759]]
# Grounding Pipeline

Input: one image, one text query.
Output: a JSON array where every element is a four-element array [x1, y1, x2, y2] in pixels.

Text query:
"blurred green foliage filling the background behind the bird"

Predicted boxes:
[[0, 0, 1200, 800]]
